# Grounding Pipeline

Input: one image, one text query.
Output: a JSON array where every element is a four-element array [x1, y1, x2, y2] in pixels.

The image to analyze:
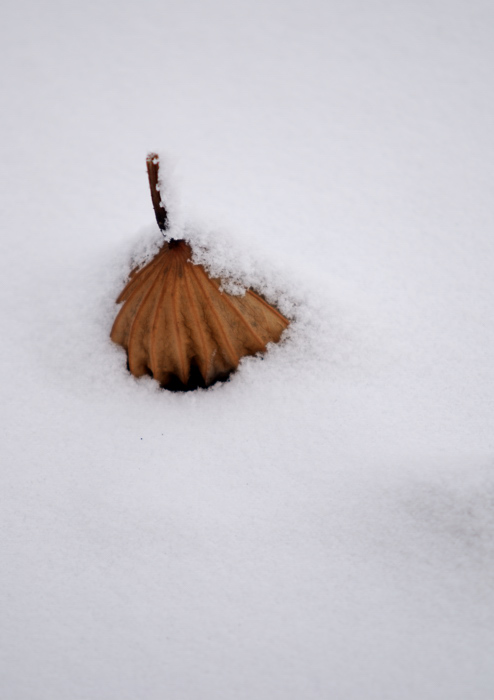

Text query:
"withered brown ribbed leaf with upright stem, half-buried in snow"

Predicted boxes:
[[111, 154, 288, 390]]
